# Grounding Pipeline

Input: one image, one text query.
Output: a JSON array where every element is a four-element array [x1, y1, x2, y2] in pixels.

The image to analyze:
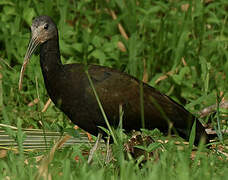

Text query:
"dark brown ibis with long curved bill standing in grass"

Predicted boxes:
[[19, 15, 209, 161]]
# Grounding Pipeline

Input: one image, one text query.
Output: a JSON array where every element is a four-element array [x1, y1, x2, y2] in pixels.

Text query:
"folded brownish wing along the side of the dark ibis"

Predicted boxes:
[[89, 66, 193, 127]]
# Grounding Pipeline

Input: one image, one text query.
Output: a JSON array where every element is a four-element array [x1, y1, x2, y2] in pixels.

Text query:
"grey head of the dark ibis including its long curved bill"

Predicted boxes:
[[19, 16, 58, 90]]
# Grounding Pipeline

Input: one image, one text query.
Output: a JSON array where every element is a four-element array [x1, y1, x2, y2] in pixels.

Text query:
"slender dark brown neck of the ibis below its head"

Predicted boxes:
[[40, 37, 63, 79]]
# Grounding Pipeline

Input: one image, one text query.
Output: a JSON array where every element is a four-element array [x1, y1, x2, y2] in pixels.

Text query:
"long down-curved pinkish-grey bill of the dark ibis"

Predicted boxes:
[[18, 38, 40, 90]]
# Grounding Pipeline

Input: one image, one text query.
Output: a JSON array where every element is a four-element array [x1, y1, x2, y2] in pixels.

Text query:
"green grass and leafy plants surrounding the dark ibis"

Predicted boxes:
[[0, 0, 228, 179]]
